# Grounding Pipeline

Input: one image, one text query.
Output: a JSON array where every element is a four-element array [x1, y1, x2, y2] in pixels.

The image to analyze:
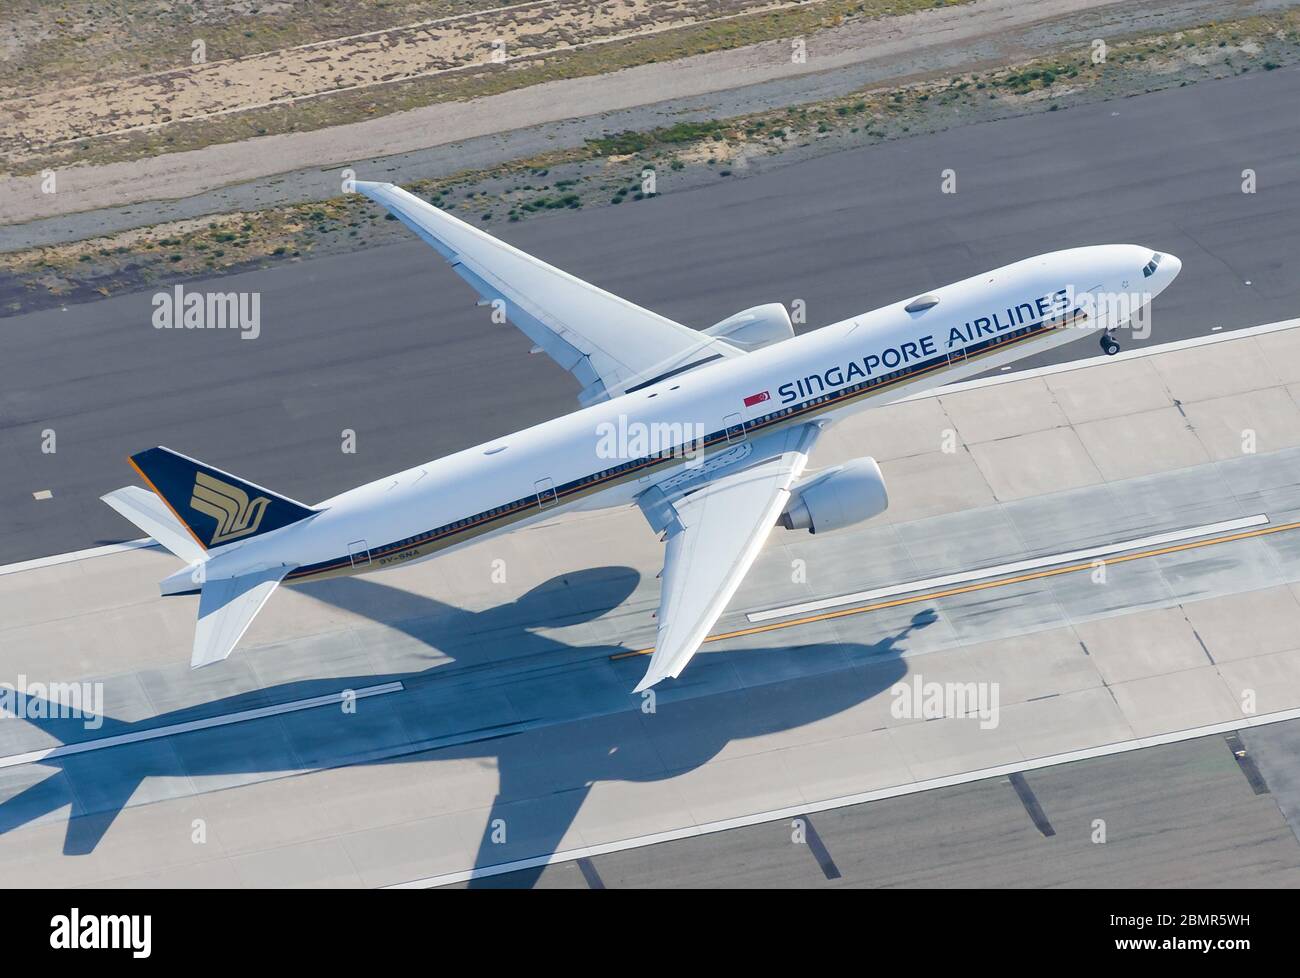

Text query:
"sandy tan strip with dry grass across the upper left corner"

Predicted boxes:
[[0, 0, 970, 173]]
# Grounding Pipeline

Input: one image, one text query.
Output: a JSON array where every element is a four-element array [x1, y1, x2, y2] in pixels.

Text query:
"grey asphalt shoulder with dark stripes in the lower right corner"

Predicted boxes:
[[486, 723, 1300, 890]]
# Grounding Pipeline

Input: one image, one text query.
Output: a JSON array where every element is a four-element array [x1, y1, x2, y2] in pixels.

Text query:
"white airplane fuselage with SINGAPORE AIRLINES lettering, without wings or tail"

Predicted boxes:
[[197, 245, 1178, 583]]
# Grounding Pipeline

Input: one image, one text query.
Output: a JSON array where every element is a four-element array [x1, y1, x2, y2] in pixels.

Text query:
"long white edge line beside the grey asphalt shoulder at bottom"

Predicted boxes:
[[384, 709, 1300, 890]]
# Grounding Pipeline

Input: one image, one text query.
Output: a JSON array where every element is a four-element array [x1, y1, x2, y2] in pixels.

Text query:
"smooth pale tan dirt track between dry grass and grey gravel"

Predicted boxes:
[[0, 0, 1118, 224]]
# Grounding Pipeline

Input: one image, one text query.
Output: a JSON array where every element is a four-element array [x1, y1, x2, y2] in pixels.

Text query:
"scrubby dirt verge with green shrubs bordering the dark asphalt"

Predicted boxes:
[[0, 10, 1300, 316]]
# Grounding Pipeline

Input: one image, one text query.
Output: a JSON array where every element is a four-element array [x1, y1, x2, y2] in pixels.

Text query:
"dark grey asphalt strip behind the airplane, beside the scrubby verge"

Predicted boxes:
[[0, 70, 1300, 562]]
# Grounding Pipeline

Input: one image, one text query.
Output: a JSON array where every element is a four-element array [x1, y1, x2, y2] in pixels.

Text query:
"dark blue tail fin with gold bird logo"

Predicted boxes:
[[127, 447, 316, 557]]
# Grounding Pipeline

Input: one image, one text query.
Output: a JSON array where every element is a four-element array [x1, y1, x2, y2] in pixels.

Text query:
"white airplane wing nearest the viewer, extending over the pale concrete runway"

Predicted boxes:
[[633, 424, 820, 693]]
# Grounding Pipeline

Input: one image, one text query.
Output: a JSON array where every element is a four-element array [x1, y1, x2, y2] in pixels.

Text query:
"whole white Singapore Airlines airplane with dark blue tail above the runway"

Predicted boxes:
[[101, 181, 1182, 693]]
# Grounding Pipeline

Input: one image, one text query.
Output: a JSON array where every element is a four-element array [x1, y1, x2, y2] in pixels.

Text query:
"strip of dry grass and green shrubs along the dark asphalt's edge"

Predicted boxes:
[[0, 5, 1300, 305]]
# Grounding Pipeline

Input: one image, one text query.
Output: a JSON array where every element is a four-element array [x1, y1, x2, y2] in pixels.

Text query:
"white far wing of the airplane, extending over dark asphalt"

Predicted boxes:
[[356, 181, 741, 404]]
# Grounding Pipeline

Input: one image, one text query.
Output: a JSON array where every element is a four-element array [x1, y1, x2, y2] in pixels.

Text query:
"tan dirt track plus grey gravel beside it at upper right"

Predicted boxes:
[[0, 0, 1295, 231]]
